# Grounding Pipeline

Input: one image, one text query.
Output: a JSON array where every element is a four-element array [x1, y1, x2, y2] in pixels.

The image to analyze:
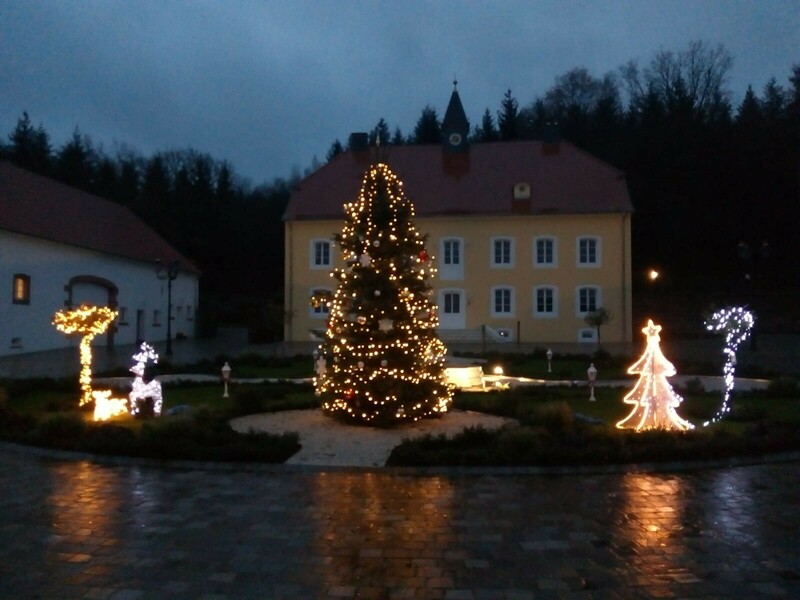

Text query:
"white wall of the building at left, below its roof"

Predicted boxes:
[[0, 230, 198, 356]]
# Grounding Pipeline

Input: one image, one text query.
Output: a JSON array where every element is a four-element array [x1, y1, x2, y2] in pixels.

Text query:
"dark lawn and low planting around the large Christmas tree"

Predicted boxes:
[[0, 355, 800, 465]]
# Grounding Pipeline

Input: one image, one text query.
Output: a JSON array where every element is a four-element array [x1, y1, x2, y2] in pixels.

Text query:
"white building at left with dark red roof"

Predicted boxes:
[[0, 163, 200, 356]]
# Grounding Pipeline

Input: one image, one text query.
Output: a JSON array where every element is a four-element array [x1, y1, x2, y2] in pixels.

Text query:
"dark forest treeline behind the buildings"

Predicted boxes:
[[0, 42, 800, 337]]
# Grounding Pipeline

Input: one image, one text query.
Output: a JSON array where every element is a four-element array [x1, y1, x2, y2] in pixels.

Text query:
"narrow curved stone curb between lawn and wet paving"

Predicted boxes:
[[0, 441, 800, 477]]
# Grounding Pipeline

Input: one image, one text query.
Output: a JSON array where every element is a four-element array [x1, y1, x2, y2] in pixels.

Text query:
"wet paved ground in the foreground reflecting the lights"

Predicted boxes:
[[0, 445, 800, 600]]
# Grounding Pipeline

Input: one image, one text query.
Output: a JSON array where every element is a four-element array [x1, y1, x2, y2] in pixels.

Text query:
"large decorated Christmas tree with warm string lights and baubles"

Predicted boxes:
[[312, 164, 452, 427]]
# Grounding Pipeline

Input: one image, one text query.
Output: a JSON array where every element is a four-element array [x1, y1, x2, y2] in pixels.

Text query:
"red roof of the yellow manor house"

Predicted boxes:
[[284, 141, 633, 220]]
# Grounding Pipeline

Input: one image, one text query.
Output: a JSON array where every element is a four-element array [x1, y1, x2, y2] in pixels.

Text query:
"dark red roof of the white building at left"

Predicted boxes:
[[0, 162, 200, 274]]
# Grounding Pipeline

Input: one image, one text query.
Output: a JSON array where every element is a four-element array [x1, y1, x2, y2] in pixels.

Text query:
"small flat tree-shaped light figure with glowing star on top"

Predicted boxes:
[[617, 320, 694, 431]]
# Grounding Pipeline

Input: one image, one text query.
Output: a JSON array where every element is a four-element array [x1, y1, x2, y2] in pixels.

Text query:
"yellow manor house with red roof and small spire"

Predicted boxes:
[[284, 91, 633, 346]]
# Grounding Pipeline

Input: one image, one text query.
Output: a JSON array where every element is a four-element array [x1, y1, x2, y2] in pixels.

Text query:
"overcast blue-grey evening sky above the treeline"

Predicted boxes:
[[0, 0, 800, 184]]
